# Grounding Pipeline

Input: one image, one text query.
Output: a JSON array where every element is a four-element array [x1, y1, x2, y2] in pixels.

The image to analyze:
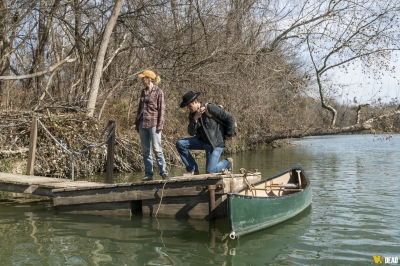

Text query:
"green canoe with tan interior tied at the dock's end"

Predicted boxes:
[[227, 164, 312, 239]]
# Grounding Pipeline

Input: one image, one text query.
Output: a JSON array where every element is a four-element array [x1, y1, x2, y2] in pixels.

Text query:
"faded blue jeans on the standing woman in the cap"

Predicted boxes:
[[139, 121, 168, 177]]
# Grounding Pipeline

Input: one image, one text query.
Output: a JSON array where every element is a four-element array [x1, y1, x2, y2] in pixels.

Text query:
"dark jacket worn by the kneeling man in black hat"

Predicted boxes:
[[188, 103, 235, 147]]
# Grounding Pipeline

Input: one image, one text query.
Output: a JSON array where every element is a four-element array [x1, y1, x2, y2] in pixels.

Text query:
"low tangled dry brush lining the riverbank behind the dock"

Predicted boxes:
[[0, 108, 399, 181]]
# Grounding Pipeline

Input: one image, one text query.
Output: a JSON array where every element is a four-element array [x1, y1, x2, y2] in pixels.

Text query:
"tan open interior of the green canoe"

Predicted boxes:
[[235, 166, 309, 197]]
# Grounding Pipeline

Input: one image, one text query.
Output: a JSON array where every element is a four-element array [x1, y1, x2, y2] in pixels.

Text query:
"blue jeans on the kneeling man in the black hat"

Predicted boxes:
[[176, 137, 230, 174]]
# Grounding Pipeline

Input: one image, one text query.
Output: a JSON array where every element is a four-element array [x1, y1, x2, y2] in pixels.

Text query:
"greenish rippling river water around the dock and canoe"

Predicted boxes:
[[0, 135, 400, 266]]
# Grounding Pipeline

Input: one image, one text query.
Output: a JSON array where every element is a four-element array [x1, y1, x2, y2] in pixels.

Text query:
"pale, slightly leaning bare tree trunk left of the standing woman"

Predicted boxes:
[[87, 0, 124, 116]]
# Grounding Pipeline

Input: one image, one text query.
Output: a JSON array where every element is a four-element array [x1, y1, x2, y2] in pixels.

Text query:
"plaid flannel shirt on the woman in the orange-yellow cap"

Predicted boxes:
[[135, 85, 165, 131]]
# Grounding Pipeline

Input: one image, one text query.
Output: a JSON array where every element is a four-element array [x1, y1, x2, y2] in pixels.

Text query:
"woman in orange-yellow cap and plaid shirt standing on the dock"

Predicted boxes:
[[135, 70, 168, 181]]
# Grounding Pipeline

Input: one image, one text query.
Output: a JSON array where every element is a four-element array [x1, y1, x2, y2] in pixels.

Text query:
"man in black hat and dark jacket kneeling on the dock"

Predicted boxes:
[[176, 91, 235, 175]]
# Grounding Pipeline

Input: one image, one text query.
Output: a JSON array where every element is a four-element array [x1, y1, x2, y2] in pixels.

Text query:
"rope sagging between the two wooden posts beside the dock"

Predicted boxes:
[[37, 119, 117, 181]]
